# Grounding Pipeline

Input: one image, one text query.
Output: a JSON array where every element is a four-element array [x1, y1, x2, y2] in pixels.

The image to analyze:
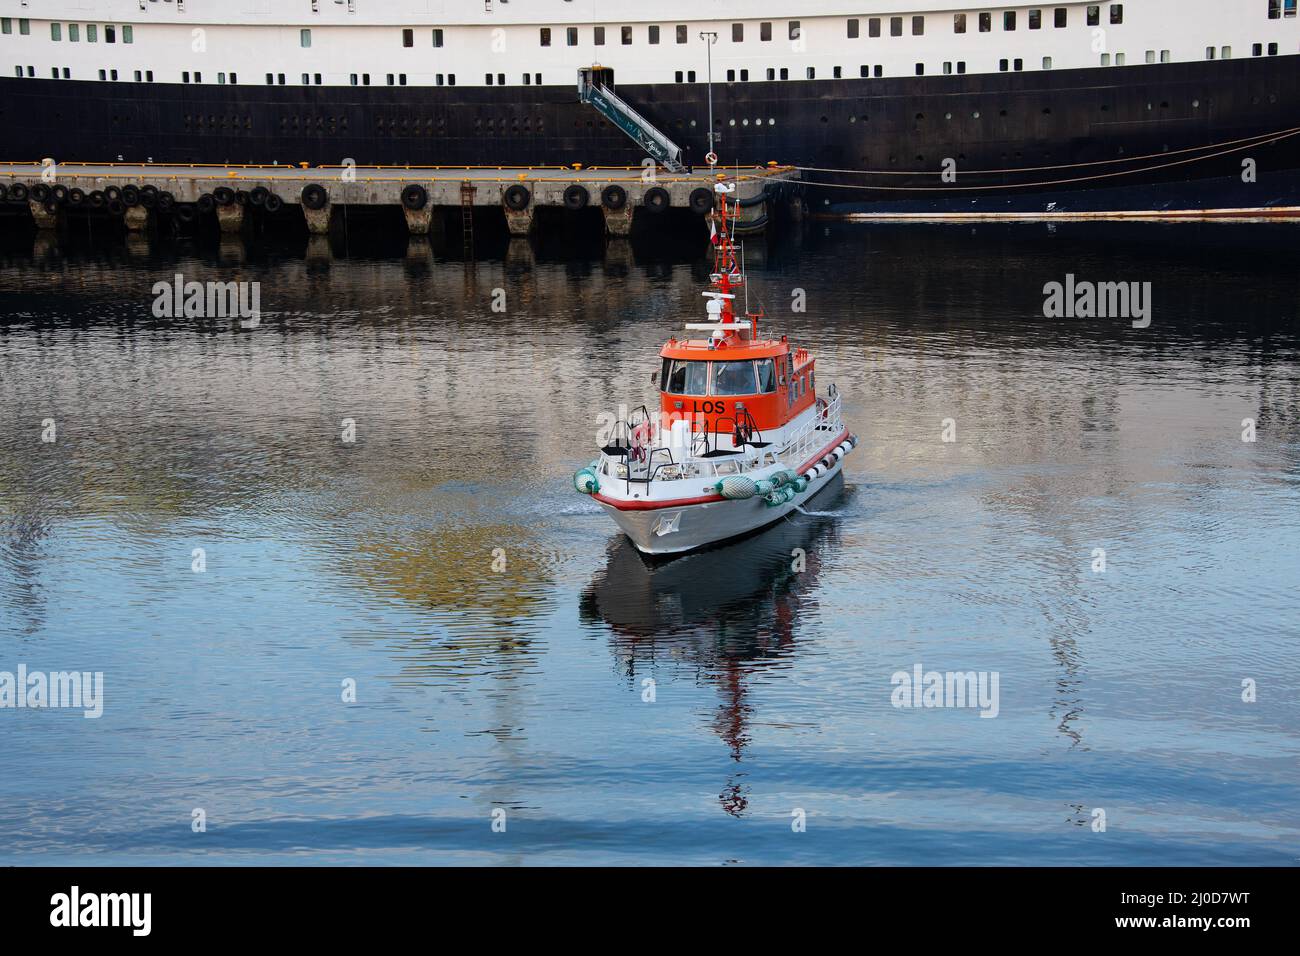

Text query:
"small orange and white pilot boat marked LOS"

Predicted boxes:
[[573, 179, 858, 554]]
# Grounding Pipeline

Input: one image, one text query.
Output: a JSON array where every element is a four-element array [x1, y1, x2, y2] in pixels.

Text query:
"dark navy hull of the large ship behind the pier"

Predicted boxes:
[[0, 56, 1300, 215]]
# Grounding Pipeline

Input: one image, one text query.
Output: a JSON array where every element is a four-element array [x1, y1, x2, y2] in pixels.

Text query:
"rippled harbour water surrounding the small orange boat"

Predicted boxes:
[[0, 224, 1300, 864]]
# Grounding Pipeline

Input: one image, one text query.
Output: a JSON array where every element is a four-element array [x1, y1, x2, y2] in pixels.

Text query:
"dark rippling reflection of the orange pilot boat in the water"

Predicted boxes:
[[580, 475, 845, 817]]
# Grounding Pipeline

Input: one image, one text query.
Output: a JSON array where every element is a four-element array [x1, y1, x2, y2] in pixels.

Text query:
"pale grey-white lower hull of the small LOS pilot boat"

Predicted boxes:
[[599, 459, 844, 554]]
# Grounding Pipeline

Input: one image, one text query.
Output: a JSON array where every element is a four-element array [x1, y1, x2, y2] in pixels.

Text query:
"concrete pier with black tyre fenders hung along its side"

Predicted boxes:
[[0, 163, 800, 237]]
